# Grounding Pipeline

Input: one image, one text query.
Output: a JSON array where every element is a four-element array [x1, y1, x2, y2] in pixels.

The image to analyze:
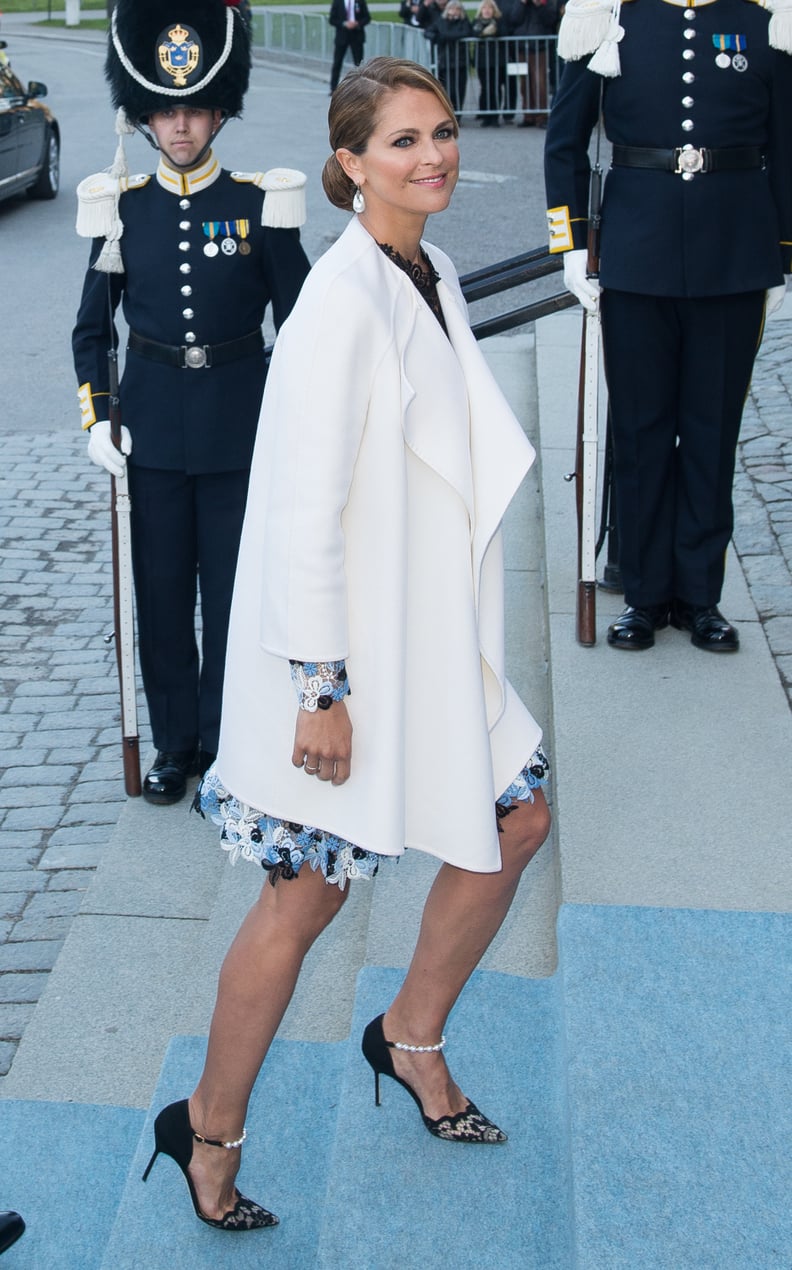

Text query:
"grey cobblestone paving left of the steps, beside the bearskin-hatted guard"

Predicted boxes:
[[0, 433, 151, 1076]]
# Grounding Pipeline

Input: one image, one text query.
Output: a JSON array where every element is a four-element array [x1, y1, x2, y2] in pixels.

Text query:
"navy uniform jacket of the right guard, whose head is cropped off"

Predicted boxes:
[[546, 0, 792, 297]]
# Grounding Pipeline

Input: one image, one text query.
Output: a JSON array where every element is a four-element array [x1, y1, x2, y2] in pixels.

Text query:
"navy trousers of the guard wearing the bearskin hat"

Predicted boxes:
[[128, 466, 249, 753]]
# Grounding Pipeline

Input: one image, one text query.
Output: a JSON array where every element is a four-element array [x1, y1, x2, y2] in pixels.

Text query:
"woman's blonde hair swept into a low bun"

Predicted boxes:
[[322, 57, 458, 212]]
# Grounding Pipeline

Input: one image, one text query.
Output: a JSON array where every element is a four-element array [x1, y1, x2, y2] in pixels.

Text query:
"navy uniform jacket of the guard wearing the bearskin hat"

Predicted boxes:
[[72, 155, 308, 475]]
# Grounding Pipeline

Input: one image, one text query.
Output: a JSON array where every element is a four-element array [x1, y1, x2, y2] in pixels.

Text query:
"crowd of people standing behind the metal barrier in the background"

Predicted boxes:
[[400, 0, 564, 128]]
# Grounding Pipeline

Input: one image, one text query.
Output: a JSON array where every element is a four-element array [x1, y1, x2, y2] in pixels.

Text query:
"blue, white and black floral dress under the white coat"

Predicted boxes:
[[194, 244, 550, 890]]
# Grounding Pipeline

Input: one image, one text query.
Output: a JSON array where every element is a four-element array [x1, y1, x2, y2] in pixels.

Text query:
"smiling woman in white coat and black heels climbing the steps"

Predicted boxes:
[[140, 57, 550, 1229]]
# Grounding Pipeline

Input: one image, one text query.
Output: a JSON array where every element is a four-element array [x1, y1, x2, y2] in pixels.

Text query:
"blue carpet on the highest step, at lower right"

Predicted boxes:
[[558, 906, 792, 1270]]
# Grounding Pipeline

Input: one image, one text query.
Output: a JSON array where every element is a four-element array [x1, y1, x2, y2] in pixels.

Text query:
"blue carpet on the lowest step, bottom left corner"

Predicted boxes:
[[0, 1100, 143, 1270]]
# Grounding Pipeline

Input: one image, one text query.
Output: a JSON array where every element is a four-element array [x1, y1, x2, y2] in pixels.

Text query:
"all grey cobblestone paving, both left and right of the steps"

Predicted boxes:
[[0, 320, 792, 1076]]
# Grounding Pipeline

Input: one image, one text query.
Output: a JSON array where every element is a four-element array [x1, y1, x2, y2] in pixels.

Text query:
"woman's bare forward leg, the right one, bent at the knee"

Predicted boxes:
[[383, 790, 550, 1120]]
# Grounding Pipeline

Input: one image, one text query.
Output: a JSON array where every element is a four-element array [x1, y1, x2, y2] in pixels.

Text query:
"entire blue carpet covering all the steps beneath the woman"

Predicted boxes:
[[0, 904, 792, 1270]]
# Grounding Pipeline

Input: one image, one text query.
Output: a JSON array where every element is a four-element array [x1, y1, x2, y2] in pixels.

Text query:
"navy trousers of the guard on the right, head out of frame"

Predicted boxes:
[[600, 290, 765, 607]]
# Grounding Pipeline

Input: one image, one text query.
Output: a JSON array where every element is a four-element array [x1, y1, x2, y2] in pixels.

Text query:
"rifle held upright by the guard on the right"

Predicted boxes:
[[572, 130, 602, 648]]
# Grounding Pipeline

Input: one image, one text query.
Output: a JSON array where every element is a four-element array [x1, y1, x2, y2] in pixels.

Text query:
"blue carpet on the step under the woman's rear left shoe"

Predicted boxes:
[[99, 1036, 347, 1270]]
